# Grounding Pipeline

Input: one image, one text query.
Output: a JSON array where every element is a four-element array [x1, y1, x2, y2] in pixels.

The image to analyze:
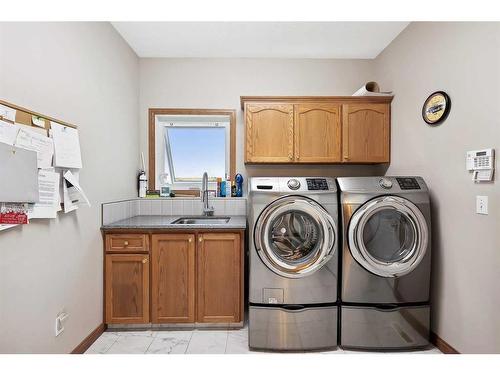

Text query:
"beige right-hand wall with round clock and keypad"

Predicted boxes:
[[375, 23, 500, 353]]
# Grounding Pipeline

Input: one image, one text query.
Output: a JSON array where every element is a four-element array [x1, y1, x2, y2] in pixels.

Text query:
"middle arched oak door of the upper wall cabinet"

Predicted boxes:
[[294, 104, 341, 163]]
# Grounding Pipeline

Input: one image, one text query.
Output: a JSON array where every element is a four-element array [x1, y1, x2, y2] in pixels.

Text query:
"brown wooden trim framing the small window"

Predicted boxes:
[[148, 108, 236, 190]]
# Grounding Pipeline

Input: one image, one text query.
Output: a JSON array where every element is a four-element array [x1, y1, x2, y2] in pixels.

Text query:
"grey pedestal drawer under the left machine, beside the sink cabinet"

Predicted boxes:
[[248, 305, 338, 350]]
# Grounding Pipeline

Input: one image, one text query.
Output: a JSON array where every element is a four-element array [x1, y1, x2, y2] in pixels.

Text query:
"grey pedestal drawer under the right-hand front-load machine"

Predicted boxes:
[[340, 305, 430, 350]]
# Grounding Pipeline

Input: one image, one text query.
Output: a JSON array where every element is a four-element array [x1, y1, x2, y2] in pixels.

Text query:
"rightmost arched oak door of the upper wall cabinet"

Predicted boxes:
[[342, 103, 390, 163]]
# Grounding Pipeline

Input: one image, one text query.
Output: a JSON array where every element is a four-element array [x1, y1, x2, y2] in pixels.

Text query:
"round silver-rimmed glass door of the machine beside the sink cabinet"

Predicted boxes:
[[254, 196, 336, 278]]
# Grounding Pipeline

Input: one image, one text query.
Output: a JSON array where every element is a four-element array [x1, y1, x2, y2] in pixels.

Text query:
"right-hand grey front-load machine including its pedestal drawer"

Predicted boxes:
[[337, 177, 431, 350]]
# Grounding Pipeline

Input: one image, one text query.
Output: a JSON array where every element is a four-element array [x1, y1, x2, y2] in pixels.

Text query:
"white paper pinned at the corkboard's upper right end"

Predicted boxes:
[[50, 121, 82, 168]]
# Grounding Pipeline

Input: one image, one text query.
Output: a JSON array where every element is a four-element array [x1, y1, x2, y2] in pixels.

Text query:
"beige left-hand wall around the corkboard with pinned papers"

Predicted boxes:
[[0, 23, 139, 353]]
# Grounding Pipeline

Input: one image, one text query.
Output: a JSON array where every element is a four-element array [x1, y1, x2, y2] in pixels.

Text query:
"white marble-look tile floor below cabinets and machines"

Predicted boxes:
[[86, 327, 441, 354]]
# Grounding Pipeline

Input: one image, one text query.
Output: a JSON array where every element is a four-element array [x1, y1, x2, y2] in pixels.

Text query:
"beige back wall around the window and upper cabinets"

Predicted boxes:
[[139, 59, 384, 184]]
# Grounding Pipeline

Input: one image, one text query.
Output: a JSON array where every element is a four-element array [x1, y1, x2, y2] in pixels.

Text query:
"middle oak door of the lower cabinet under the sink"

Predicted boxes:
[[151, 233, 195, 323]]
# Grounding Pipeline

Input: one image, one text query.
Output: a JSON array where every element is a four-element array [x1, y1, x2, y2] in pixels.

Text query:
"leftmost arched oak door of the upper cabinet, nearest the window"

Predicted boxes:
[[245, 104, 293, 163]]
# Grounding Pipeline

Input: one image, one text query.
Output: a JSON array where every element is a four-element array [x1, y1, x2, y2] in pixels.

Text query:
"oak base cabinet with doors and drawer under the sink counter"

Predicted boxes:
[[104, 231, 244, 324]]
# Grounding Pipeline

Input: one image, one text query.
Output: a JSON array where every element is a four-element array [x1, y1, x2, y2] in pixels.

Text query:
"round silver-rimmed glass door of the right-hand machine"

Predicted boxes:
[[348, 196, 428, 277]]
